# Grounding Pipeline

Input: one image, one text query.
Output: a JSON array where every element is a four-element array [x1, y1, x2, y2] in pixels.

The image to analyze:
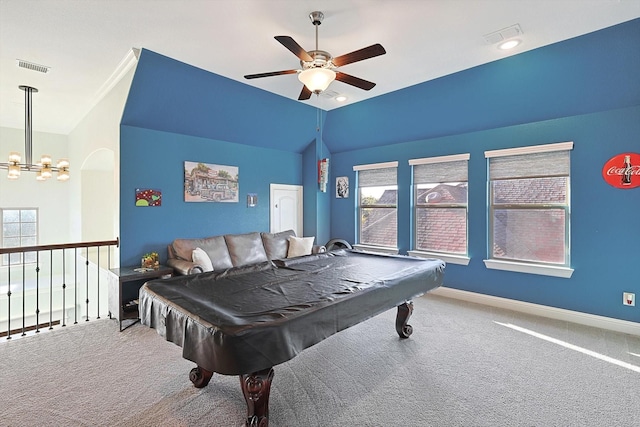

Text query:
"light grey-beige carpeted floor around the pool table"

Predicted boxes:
[[0, 296, 640, 427]]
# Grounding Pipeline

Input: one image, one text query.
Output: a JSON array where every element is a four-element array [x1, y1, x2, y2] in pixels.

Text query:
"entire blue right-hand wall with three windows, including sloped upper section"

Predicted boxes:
[[325, 19, 640, 322]]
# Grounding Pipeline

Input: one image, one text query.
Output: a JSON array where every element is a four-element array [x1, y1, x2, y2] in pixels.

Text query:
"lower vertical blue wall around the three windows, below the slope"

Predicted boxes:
[[331, 107, 640, 322]]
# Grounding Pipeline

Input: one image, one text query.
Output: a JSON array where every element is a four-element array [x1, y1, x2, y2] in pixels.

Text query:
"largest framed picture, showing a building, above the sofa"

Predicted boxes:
[[184, 162, 238, 203]]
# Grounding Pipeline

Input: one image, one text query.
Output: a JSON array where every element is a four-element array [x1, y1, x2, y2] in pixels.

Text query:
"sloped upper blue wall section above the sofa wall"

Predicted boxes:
[[121, 49, 317, 153]]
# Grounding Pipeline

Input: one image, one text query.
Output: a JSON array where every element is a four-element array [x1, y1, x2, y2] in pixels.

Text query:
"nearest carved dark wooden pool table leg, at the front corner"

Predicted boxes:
[[240, 368, 273, 427]]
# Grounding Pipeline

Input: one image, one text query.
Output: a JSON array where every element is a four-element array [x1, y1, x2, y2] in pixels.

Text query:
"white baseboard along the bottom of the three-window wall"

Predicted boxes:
[[429, 287, 640, 336]]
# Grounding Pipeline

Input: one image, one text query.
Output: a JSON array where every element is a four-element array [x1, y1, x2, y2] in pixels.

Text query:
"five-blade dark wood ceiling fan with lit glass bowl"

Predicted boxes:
[[244, 11, 387, 101]]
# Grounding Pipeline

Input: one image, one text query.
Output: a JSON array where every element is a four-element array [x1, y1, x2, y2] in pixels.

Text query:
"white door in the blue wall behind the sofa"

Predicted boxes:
[[269, 184, 302, 237]]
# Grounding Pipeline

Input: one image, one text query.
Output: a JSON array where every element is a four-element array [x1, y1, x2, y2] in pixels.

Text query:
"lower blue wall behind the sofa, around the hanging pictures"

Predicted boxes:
[[120, 126, 302, 265]]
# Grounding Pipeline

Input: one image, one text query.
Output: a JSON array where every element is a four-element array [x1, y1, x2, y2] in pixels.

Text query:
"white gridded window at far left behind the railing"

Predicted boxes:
[[0, 209, 38, 265]]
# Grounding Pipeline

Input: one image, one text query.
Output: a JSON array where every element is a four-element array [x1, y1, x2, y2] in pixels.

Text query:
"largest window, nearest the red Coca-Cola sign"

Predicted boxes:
[[485, 142, 573, 277]]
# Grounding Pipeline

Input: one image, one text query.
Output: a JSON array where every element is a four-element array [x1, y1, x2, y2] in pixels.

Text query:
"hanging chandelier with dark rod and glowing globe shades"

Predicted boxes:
[[0, 85, 69, 181]]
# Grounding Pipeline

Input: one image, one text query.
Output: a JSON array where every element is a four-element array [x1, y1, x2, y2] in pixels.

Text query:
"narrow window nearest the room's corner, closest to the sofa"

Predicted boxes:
[[353, 162, 398, 249]]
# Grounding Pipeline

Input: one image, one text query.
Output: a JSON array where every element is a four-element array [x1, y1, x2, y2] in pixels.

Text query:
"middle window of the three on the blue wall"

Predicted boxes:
[[409, 154, 469, 265]]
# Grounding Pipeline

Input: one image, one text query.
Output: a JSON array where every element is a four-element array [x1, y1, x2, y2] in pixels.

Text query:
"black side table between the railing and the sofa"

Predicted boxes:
[[109, 265, 173, 332]]
